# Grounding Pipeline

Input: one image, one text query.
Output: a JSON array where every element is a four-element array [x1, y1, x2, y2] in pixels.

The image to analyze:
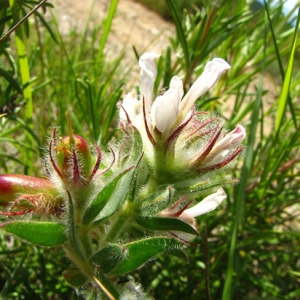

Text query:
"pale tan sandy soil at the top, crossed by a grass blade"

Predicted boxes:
[[52, 0, 175, 63]]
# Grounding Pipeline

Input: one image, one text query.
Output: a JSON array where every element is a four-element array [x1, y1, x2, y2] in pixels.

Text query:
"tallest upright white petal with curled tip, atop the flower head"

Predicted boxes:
[[139, 52, 159, 109]]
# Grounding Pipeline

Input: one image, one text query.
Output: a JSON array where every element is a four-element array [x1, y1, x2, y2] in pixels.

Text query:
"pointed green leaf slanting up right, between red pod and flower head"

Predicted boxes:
[[82, 167, 133, 225]]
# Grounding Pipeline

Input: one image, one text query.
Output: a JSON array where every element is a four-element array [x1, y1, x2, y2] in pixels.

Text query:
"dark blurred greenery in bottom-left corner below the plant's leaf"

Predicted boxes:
[[0, 234, 76, 299]]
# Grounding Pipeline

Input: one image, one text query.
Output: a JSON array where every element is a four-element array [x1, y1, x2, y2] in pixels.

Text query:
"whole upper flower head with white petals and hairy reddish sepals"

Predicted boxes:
[[120, 52, 245, 182]]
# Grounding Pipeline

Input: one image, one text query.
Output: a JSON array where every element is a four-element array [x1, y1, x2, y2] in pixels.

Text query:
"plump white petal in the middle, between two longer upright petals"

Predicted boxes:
[[151, 76, 183, 135]]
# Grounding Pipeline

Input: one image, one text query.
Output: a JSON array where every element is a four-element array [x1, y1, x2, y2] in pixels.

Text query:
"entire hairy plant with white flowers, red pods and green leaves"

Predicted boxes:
[[0, 52, 245, 299]]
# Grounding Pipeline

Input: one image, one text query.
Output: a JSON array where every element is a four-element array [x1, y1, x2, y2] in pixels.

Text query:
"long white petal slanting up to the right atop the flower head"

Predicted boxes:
[[180, 58, 230, 113]]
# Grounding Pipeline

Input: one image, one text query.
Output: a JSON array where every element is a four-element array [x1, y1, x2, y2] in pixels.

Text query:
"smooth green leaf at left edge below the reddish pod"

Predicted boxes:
[[0, 221, 66, 247]]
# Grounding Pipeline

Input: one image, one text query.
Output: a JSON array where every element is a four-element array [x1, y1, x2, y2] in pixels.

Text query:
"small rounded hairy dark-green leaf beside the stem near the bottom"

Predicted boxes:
[[89, 244, 124, 273]]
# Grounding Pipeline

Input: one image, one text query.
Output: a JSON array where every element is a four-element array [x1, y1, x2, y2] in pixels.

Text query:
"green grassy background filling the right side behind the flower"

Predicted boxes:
[[135, 1, 300, 299]]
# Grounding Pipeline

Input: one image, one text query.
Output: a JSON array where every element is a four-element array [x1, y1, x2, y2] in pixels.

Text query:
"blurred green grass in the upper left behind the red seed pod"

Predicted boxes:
[[0, 1, 126, 175]]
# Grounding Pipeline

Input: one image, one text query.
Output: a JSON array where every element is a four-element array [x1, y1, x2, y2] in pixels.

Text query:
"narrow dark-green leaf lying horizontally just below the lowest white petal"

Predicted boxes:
[[135, 217, 198, 235]]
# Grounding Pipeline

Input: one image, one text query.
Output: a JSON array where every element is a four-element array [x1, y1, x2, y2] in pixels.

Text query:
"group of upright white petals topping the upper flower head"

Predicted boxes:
[[120, 52, 230, 138]]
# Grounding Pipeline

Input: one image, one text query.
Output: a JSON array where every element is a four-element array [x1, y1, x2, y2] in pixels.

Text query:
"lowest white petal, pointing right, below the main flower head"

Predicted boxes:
[[184, 189, 227, 218]]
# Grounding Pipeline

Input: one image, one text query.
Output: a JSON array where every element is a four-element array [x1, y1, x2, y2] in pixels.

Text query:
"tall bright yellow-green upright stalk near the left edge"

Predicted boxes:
[[9, 0, 33, 170]]
